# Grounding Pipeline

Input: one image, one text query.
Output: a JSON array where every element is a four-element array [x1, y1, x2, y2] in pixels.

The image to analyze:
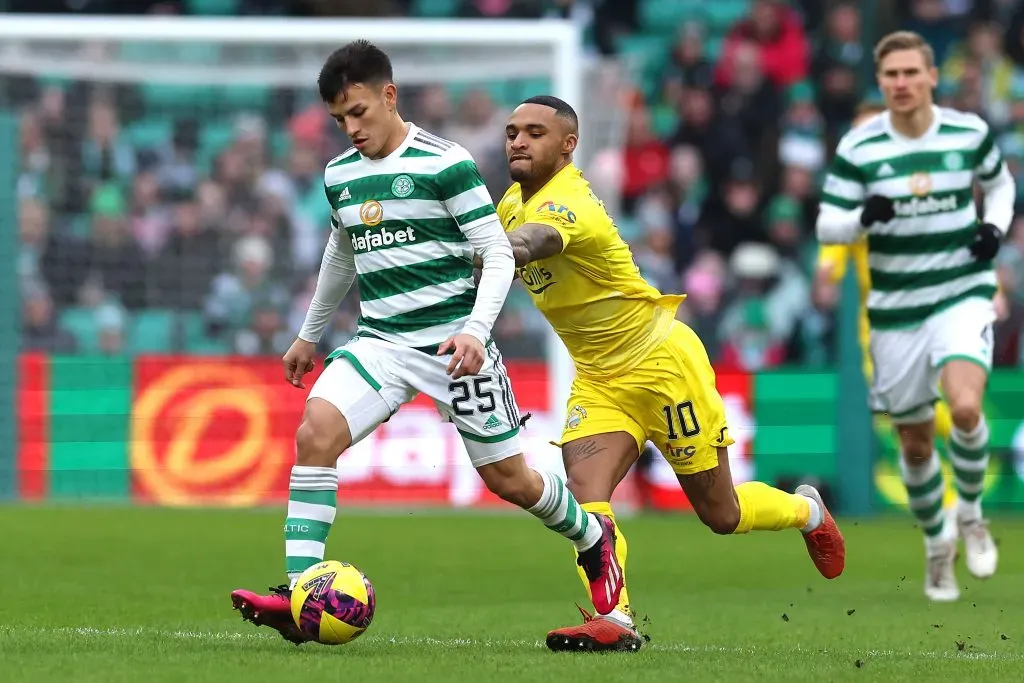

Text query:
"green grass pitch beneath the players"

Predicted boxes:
[[0, 507, 1024, 683]]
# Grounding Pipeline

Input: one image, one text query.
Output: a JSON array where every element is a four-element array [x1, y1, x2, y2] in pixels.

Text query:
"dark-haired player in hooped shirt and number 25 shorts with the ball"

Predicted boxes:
[[231, 41, 623, 643]]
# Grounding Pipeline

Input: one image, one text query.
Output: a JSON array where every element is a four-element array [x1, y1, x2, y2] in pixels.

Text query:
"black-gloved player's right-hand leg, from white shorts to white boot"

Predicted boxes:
[[935, 299, 998, 579]]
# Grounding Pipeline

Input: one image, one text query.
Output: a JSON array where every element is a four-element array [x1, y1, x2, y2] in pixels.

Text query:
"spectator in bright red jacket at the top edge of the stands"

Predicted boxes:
[[715, 0, 810, 88]]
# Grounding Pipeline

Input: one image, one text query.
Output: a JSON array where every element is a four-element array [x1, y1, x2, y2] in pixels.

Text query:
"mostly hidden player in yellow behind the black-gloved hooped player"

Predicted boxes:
[[815, 102, 953, 442]]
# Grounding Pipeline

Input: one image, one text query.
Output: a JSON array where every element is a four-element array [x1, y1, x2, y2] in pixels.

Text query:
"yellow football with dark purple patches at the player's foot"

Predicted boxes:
[[292, 560, 375, 645]]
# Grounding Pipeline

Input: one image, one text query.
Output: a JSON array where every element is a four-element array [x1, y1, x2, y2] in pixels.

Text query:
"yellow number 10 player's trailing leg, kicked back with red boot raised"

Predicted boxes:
[[655, 324, 846, 579]]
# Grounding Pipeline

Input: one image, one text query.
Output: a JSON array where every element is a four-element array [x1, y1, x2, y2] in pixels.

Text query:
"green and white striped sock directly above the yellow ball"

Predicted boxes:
[[285, 465, 338, 586]]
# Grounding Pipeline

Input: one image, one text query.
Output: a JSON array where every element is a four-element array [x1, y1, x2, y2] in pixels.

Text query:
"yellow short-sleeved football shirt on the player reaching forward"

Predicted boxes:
[[498, 164, 685, 378]]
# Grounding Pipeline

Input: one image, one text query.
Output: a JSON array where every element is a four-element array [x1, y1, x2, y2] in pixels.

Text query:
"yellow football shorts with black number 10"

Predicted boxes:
[[561, 321, 735, 474]]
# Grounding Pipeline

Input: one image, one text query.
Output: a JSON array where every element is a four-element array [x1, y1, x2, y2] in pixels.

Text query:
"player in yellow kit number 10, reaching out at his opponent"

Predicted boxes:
[[498, 95, 846, 651]]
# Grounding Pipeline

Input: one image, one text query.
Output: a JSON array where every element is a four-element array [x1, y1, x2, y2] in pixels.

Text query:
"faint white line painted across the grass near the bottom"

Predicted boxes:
[[0, 625, 1024, 661]]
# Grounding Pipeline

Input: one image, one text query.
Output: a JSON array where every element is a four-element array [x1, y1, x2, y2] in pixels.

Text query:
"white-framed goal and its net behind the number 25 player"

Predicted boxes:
[[0, 15, 629, 505]]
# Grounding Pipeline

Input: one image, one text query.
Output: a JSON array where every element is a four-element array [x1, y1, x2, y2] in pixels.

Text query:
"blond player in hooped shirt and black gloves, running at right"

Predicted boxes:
[[817, 32, 1016, 601]]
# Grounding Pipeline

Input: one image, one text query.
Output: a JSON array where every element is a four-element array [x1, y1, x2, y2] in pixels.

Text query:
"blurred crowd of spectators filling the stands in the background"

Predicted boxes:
[[9, 0, 1024, 370]]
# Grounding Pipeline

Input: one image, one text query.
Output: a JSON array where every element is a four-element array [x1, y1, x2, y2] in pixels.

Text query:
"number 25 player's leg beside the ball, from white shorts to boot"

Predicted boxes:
[[231, 341, 411, 644]]
